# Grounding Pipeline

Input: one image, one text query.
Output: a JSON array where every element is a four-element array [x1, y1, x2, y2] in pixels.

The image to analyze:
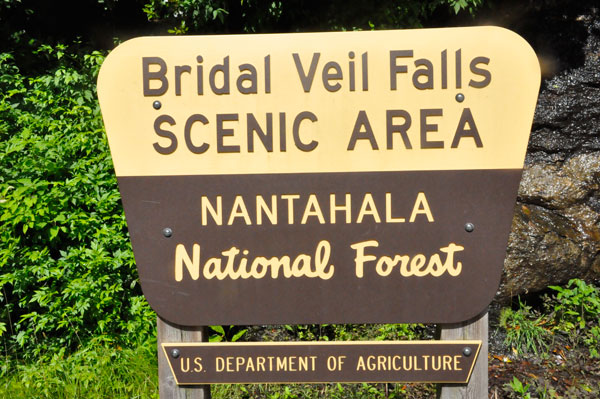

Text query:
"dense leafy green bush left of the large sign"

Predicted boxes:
[[0, 45, 155, 357]]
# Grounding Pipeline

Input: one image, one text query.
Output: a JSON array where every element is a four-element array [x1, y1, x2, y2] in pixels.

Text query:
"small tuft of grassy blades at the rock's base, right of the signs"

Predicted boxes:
[[500, 300, 552, 356]]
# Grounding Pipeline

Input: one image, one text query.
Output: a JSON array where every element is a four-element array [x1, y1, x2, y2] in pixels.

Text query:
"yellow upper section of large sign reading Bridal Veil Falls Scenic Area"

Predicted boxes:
[[98, 27, 540, 176]]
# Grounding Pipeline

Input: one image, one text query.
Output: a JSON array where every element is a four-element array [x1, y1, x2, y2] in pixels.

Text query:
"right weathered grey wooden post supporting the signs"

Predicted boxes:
[[437, 310, 489, 399]]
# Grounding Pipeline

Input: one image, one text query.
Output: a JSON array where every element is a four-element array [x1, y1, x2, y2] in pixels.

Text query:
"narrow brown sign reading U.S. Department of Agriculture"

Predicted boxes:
[[162, 341, 481, 385]]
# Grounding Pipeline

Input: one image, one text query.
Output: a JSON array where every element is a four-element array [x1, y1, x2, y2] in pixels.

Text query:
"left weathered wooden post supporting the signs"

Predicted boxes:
[[157, 317, 210, 399]]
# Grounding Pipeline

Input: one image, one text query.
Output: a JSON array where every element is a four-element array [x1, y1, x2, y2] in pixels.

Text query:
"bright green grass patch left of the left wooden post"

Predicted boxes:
[[0, 341, 158, 399]]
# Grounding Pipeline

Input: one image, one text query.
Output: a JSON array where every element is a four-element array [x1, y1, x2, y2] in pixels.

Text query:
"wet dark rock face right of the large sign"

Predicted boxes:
[[497, 1, 600, 300]]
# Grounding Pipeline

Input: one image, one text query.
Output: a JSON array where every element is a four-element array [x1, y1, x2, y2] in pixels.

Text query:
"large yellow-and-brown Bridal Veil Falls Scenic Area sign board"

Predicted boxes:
[[98, 27, 540, 326]]
